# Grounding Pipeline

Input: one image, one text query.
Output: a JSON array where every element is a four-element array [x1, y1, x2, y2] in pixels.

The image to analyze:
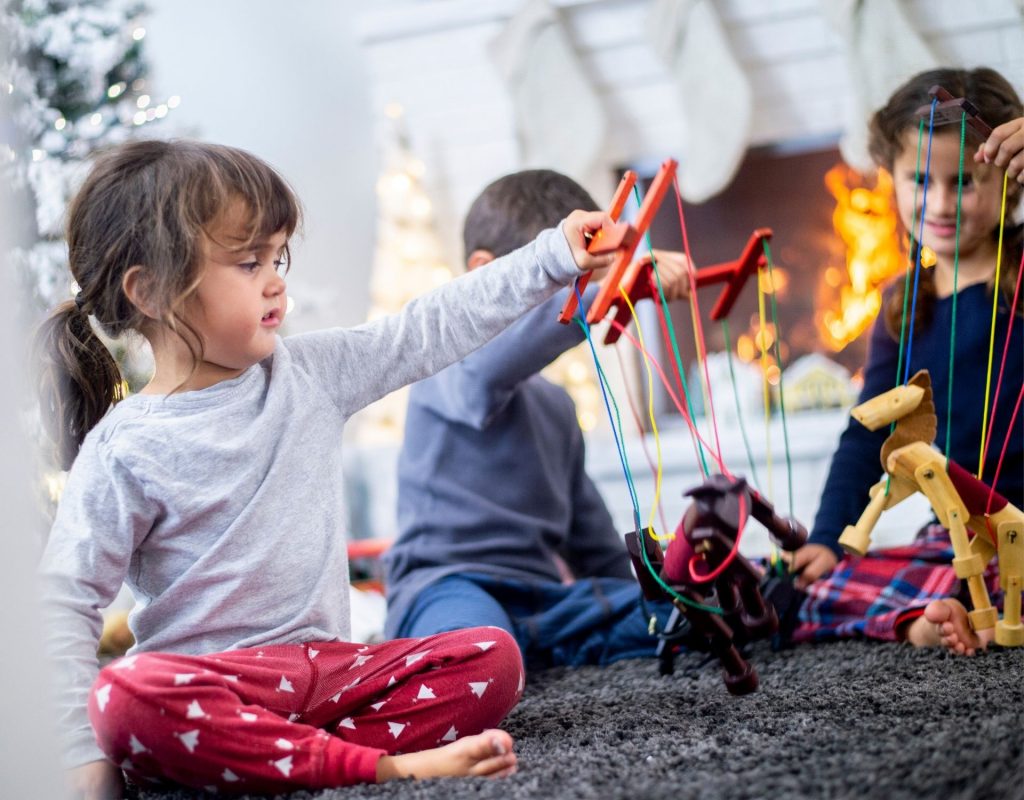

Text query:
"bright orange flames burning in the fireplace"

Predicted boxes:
[[815, 164, 904, 350]]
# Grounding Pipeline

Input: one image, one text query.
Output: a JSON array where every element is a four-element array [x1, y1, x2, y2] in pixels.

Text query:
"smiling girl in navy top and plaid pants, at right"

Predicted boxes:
[[793, 69, 1024, 654]]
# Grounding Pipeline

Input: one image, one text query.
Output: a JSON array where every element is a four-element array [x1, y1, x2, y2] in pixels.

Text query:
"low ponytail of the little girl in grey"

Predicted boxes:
[[35, 300, 124, 469]]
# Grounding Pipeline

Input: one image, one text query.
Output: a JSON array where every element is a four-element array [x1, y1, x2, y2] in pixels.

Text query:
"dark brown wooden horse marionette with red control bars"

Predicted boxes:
[[558, 159, 807, 694]]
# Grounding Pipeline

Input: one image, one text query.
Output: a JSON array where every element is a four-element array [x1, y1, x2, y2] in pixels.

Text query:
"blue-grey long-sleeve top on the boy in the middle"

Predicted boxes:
[[385, 284, 632, 636]]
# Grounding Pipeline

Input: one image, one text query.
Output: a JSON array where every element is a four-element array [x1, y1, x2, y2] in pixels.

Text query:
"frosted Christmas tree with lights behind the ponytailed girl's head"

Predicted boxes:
[[0, 0, 178, 323]]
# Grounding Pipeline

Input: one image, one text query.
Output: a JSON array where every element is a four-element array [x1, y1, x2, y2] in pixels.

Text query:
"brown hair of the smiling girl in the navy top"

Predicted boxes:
[[868, 67, 1024, 339]]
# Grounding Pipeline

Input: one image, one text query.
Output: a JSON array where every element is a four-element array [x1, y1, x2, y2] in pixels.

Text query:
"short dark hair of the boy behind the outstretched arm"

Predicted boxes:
[[462, 169, 598, 258]]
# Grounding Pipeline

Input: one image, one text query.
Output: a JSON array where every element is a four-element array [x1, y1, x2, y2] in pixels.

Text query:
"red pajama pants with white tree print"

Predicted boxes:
[[89, 628, 523, 794]]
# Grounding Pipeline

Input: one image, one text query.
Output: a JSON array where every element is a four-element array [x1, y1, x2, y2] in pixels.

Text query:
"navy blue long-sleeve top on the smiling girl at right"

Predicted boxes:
[[809, 284, 1024, 555]]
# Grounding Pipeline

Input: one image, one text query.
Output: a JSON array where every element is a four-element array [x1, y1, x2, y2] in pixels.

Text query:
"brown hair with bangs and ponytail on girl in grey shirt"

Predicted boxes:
[[36, 140, 301, 469]]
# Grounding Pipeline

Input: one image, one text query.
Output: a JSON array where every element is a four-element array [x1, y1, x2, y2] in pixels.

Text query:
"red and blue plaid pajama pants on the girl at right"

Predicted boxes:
[[793, 523, 998, 641]]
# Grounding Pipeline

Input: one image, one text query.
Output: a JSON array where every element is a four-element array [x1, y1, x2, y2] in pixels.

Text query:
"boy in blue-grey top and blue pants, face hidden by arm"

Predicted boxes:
[[385, 170, 687, 668]]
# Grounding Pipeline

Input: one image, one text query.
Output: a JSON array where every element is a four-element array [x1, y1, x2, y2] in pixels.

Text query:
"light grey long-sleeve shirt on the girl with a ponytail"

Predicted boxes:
[[42, 229, 580, 766]]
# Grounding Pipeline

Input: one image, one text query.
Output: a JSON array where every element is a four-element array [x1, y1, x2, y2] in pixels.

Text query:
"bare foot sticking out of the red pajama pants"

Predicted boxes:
[[377, 729, 516, 784]]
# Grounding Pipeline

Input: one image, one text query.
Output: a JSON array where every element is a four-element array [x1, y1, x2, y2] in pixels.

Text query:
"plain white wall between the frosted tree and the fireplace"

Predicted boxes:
[[144, 0, 376, 333]]
